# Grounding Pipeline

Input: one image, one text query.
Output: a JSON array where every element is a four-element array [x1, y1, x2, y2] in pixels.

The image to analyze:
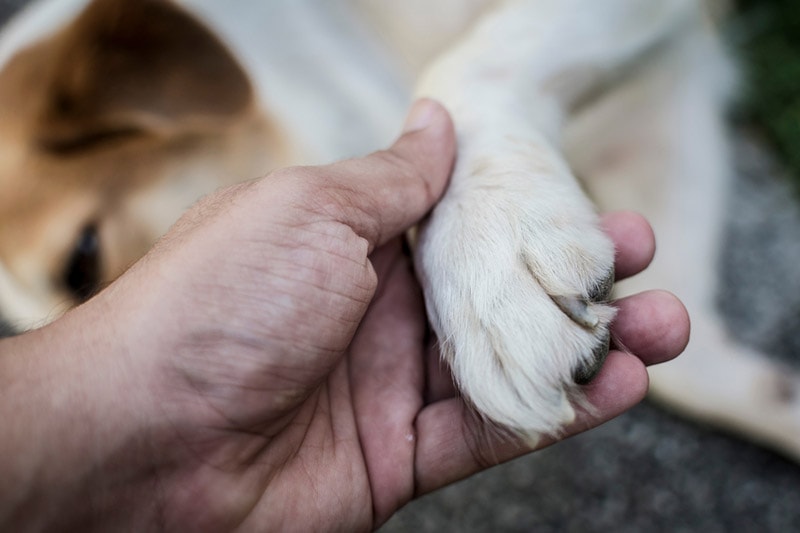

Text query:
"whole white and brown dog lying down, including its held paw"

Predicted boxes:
[[0, 0, 800, 458]]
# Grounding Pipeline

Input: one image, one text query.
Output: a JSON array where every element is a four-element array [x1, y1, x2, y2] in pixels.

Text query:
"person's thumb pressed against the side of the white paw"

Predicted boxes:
[[318, 99, 456, 250]]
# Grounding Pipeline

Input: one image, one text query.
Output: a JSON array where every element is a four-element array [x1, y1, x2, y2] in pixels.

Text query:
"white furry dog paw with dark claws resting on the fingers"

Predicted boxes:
[[416, 157, 614, 442]]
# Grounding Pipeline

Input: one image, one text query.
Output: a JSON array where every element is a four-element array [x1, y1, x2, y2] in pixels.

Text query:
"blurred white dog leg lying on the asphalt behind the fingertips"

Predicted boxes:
[[565, 21, 800, 459]]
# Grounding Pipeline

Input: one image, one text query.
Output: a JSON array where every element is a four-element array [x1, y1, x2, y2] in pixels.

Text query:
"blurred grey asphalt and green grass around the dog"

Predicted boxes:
[[0, 0, 800, 533]]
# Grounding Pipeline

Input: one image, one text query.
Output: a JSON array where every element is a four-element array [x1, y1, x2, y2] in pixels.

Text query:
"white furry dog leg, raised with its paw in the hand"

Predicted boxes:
[[417, 0, 695, 441]]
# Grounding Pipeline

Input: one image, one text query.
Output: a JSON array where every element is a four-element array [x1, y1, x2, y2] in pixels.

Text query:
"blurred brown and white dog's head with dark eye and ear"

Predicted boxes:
[[0, 0, 282, 328]]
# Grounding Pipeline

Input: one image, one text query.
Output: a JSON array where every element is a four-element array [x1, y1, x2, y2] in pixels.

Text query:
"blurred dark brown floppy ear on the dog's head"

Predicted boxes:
[[37, 0, 252, 151]]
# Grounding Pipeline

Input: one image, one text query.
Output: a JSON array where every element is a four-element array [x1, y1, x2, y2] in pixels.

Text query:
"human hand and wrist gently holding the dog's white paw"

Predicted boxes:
[[0, 104, 688, 531]]
